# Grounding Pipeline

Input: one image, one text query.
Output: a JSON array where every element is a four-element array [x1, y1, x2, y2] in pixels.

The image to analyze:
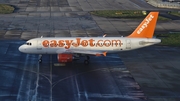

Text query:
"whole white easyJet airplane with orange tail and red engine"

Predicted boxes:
[[19, 12, 161, 64]]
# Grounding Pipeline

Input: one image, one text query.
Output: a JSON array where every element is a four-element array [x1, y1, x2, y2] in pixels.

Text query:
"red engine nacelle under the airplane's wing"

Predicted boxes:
[[57, 54, 73, 63]]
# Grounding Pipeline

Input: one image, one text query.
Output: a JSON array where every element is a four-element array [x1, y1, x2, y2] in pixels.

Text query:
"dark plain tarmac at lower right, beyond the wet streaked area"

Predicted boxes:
[[119, 46, 180, 101]]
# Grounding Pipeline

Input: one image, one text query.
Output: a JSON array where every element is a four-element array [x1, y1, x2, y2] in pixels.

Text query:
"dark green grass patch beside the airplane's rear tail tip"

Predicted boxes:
[[157, 33, 180, 47]]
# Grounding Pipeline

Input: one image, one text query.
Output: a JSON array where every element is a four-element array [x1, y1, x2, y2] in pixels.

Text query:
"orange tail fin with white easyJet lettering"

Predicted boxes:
[[127, 12, 159, 38]]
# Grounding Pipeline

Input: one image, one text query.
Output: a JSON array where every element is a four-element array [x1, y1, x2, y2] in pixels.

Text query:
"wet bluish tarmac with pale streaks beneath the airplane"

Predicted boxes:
[[0, 40, 146, 101]]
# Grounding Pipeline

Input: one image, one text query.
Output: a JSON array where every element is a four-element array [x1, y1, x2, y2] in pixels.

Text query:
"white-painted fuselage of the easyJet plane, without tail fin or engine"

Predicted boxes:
[[19, 37, 161, 54]]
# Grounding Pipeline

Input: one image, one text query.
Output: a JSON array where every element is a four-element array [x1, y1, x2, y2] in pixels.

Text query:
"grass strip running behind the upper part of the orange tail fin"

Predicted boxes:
[[90, 10, 170, 20]]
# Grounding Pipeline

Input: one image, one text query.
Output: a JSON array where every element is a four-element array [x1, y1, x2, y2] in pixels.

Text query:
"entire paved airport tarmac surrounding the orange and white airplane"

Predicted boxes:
[[0, 0, 180, 101]]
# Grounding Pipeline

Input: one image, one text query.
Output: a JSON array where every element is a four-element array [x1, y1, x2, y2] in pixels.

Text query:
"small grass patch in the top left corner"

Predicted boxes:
[[0, 4, 14, 14]]
